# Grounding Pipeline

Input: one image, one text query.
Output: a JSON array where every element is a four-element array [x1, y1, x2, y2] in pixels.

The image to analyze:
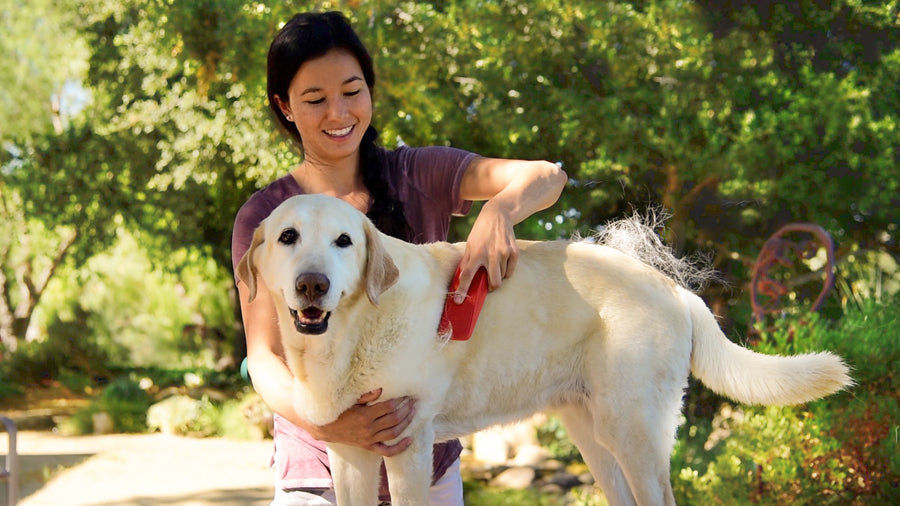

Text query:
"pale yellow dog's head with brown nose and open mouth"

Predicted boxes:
[[237, 195, 399, 334]]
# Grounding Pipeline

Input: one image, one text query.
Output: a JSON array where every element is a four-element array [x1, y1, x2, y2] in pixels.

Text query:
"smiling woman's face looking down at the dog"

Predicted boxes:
[[276, 49, 372, 163]]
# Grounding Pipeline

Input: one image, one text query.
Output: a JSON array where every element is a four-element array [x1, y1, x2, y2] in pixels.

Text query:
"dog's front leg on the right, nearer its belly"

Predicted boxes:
[[384, 422, 434, 506]]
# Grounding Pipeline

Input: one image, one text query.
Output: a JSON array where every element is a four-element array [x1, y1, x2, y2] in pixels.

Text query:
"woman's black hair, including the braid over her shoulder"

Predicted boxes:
[[266, 12, 412, 240]]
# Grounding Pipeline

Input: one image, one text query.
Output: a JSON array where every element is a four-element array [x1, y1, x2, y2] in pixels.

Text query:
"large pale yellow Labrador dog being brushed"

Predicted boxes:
[[238, 195, 852, 505]]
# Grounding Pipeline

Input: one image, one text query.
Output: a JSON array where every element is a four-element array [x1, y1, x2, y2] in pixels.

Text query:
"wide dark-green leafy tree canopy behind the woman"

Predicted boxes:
[[8, 0, 900, 344]]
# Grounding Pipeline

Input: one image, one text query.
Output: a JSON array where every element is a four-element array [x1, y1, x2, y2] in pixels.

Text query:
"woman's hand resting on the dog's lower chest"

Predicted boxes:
[[307, 389, 416, 457]]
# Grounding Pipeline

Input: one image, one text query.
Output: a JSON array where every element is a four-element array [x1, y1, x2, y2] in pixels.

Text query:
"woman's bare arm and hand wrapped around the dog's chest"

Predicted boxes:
[[238, 280, 415, 457]]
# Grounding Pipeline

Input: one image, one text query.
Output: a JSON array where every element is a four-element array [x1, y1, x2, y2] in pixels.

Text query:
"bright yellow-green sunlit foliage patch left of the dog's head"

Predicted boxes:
[[26, 230, 240, 369]]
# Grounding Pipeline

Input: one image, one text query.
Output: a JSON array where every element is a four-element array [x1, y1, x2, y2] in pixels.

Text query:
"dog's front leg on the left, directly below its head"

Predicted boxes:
[[327, 444, 381, 506]]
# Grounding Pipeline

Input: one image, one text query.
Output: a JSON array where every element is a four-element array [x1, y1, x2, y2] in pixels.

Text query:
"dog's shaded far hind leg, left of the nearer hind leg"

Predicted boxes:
[[556, 404, 637, 506]]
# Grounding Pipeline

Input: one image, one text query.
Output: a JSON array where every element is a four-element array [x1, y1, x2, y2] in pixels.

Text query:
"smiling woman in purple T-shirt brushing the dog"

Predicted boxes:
[[232, 12, 566, 504]]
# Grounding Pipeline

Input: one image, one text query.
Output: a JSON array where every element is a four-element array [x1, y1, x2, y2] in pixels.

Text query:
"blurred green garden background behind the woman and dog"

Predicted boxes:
[[0, 0, 900, 504]]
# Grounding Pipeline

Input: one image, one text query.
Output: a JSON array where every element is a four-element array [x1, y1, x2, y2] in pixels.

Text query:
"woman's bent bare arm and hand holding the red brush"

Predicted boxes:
[[456, 157, 568, 303]]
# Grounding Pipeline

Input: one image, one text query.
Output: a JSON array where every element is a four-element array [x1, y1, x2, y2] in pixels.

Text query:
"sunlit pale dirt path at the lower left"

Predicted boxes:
[[0, 432, 274, 506]]
